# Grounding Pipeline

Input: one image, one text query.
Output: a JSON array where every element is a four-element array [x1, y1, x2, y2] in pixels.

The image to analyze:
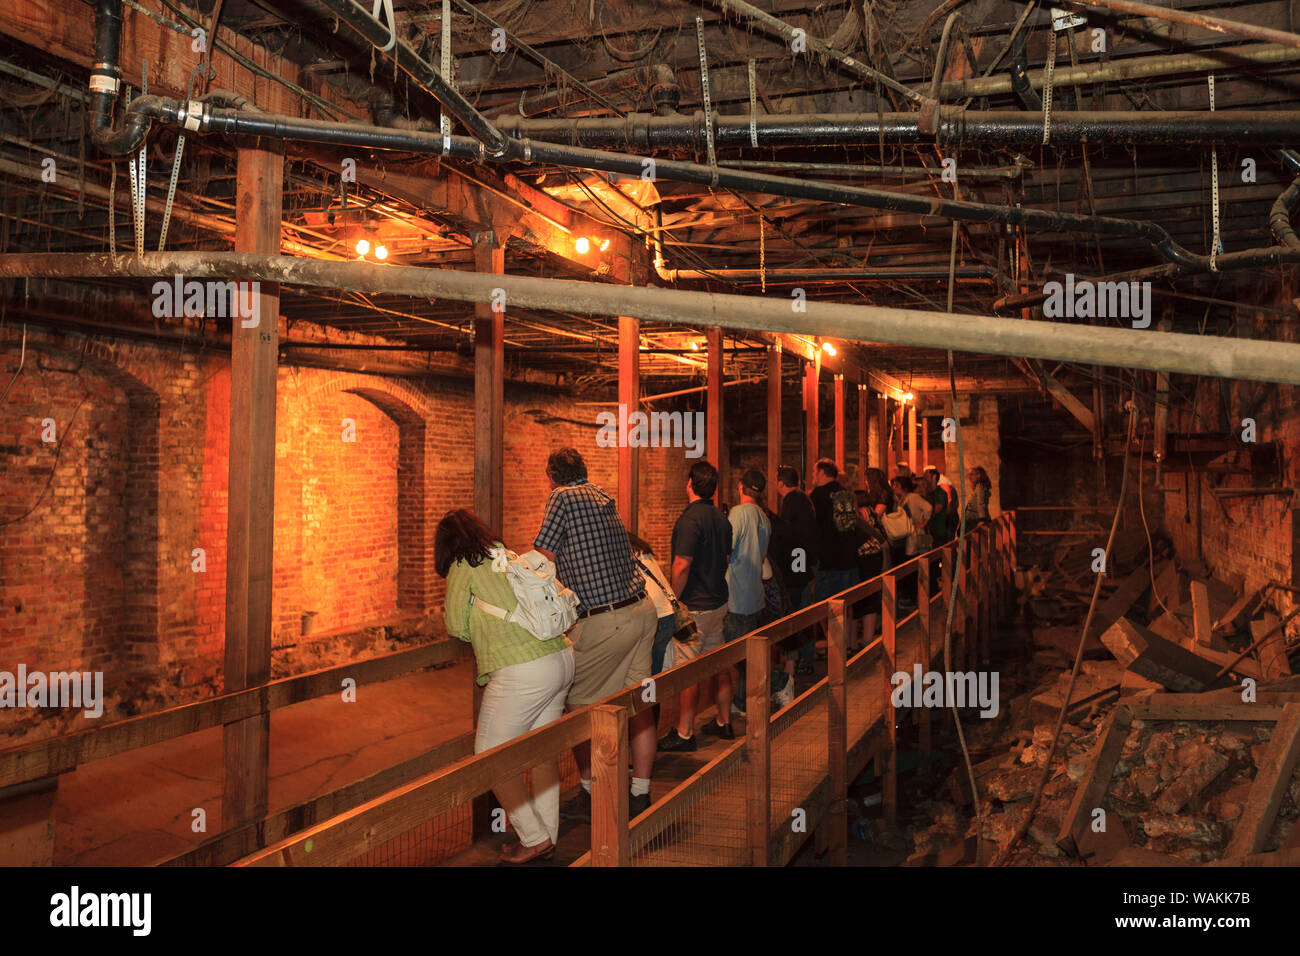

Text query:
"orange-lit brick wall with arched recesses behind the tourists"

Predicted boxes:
[[0, 326, 689, 731]]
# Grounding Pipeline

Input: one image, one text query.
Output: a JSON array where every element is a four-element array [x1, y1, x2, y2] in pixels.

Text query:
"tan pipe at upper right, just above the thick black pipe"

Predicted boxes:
[[939, 44, 1300, 100]]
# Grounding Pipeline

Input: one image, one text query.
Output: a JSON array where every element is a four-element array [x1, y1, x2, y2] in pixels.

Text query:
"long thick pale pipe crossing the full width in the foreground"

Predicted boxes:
[[0, 252, 1300, 385]]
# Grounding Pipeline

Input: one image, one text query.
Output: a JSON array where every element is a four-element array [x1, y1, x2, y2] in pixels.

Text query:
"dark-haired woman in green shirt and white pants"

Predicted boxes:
[[434, 509, 573, 864]]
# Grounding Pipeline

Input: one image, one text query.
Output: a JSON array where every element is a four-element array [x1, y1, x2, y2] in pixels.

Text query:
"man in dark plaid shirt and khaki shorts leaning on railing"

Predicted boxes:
[[533, 449, 659, 821]]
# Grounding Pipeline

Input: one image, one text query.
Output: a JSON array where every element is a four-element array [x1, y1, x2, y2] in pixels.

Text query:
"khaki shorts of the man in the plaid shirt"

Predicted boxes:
[[568, 597, 659, 708]]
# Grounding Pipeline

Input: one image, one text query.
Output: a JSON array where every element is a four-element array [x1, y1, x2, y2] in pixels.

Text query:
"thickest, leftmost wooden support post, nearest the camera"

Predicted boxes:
[[221, 138, 285, 852]]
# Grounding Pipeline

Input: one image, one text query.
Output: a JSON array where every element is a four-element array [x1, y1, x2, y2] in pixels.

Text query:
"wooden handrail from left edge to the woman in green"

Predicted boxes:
[[0, 640, 471, 787]]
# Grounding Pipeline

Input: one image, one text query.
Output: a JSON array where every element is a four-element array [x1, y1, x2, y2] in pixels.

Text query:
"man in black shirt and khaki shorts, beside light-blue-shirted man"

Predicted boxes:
[[659, 459, 735, 752]]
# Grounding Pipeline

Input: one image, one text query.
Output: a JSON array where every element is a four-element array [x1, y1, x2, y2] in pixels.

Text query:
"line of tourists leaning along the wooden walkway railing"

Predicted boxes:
[[434, 449, 989, 864]]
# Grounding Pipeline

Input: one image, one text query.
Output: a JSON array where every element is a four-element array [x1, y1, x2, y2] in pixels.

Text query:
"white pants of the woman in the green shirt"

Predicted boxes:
[[475, 648, 573, 847]]
